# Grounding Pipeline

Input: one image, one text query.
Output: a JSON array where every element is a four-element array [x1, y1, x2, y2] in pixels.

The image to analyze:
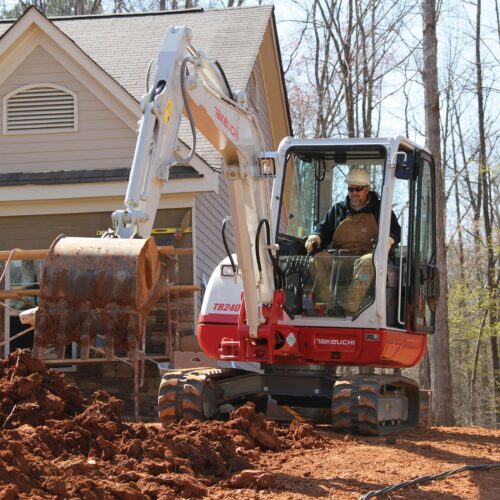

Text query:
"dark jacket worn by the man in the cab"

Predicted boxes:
[[313, 191, 401, 249]]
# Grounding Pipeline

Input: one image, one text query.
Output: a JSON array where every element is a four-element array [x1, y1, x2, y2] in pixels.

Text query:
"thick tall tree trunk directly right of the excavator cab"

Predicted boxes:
[[422, 0, 454, 425]]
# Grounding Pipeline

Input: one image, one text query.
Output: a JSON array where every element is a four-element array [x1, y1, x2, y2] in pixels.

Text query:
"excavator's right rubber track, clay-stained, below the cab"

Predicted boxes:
[[332, 375, 418, 436]]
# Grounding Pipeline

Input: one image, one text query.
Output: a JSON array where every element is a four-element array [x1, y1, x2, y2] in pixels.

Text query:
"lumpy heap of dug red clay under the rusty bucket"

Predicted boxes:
[[0, 351, 324, 499]]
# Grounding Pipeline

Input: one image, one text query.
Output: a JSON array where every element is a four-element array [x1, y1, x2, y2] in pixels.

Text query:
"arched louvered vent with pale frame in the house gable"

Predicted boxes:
[[3, 83, 78, 134]]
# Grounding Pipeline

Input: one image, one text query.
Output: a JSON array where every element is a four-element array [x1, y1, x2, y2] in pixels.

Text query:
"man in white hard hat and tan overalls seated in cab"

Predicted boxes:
[[305, 168, 401, 314]]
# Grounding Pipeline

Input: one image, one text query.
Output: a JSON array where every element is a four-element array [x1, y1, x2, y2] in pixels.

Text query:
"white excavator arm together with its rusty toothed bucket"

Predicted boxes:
[[34, 26, 275, 358]]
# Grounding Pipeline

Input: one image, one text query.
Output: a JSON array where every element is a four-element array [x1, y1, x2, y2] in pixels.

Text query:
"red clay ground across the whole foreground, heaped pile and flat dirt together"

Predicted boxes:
[[0, 351, 500, 500]]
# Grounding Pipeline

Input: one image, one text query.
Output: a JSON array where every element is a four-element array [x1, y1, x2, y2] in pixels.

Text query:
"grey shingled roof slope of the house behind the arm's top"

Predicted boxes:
[[0, 5, 273, 100]]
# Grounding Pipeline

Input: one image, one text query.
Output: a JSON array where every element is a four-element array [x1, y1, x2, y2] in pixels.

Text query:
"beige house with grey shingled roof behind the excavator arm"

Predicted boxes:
[[0, 6, 291, 416]]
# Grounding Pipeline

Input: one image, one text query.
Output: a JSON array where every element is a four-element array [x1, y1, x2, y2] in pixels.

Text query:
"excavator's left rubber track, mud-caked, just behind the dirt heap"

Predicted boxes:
[[158, 368, 231, 423]]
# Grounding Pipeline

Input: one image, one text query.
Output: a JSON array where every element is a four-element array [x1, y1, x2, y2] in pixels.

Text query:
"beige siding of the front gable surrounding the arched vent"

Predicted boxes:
[[0, 46, 135, 173]]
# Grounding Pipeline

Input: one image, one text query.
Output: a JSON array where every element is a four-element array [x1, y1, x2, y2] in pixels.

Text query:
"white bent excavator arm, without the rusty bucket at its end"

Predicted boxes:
[[112, 26, 274, 337]]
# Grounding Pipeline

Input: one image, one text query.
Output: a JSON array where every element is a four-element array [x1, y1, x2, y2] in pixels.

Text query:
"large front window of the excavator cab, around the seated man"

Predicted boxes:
[[277, 145, 386, 321]]
